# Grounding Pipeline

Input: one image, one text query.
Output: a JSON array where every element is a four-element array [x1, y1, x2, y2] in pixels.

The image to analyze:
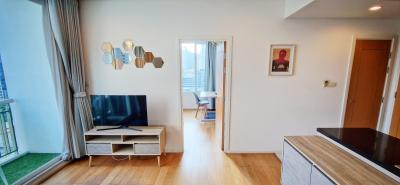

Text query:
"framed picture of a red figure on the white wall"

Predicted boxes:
[[269, 44, 296, 76]]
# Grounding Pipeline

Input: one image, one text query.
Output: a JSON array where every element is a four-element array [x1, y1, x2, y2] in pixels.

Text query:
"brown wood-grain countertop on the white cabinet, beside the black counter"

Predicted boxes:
[[285, 136, 400, 185]]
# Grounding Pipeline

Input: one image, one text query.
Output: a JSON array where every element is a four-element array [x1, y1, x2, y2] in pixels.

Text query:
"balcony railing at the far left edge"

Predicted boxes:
[[0, 99, 18, 158]]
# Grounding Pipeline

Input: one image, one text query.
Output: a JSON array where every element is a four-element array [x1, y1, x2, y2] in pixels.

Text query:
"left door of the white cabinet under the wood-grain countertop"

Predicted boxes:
[[281, 141, 312, 185]]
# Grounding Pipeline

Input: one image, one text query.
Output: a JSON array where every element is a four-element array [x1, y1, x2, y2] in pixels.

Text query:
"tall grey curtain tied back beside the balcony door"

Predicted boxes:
[[43, 0, 93, 160]]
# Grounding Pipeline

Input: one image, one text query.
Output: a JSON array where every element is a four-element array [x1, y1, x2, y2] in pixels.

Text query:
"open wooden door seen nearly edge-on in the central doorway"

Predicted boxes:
[[215, 42, 226, 150]]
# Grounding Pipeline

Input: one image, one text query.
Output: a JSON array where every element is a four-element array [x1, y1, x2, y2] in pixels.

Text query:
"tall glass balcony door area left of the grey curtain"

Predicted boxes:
[[0, 1, 64, 184]]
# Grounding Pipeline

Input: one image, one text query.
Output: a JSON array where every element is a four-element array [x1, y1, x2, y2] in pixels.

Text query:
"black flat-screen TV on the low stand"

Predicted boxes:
[[91, 95, 148, 126]]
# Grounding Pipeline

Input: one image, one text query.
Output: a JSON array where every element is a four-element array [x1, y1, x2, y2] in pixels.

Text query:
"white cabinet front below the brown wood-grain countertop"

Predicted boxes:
[[281, 141, 335, 185]]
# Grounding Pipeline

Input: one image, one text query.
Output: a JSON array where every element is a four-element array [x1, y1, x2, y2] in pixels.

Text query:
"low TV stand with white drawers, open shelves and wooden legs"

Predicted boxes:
[[85, 126, 165, 166]]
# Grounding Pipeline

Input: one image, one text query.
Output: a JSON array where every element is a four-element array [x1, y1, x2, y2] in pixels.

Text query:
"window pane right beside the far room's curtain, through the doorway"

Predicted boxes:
[[196, 42, 207, 91]]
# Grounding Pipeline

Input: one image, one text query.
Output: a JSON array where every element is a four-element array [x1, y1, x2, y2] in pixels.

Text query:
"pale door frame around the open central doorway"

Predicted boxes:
[[177, 36, 233, 153]]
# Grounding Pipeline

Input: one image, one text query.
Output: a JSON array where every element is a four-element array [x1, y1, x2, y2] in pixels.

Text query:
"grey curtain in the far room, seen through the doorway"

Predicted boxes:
[[206, 42, 217, 109]]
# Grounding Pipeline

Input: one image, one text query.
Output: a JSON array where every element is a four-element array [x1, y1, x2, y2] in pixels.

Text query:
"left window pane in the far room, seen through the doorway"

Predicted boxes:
[[182, 43, 196, 92]]
